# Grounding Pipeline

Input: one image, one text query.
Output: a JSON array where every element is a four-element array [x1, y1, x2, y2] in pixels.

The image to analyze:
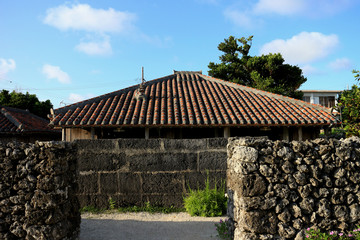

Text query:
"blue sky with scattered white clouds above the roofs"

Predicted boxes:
[[0, 0, 360, 108]]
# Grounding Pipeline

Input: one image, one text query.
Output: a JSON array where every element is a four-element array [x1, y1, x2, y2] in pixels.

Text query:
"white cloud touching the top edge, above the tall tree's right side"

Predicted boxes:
[[253, 0, 305, 15]]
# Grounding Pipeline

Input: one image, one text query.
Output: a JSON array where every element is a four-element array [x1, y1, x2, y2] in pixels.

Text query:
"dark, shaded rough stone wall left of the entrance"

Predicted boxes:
[[0, 142, 80, 240]]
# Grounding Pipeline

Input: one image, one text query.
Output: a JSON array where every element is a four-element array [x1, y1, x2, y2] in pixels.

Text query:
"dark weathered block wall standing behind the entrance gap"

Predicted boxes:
[[75, 138, 227, 208]]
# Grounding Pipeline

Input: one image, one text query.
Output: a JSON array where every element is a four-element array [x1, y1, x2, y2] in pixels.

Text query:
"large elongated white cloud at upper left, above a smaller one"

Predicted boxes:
[[44, 4, 136, 33]]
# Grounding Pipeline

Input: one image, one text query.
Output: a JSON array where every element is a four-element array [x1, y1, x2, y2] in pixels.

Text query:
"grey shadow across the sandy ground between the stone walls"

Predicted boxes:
[[80, 219, 218, 240]]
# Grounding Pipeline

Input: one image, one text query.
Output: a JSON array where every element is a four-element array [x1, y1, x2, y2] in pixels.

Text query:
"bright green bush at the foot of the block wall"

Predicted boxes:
[[184, 173, 227, 217]]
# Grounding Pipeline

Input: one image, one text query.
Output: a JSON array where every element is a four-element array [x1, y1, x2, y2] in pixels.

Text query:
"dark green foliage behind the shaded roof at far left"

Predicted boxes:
[[0, 90, 53, 119]]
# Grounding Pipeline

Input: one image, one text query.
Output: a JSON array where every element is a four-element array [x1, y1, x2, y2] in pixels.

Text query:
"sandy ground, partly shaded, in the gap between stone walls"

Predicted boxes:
[[80, 212, 226, 240]]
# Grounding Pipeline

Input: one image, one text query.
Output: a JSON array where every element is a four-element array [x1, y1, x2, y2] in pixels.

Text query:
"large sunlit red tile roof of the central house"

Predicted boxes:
[[51, 72, 336, 127]]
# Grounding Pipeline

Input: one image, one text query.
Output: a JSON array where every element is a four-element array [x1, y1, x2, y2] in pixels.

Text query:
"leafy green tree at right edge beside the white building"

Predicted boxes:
[[337, 70, 360, 136]]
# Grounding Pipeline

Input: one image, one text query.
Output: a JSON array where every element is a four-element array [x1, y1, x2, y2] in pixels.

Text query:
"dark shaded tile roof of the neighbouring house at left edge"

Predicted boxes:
[[0, 107, 54, 133]]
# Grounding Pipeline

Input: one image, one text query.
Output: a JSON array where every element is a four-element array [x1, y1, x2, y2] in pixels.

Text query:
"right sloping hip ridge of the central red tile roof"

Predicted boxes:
[[202, 75, 331, 112]]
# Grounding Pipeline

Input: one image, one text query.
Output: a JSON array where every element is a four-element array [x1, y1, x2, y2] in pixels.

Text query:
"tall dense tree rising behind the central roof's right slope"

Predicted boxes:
[[208, 36, 307, 99]]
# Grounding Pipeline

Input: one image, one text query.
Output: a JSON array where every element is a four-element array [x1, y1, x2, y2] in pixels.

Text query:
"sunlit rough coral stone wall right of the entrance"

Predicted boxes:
[[227, 138, 360, 240]]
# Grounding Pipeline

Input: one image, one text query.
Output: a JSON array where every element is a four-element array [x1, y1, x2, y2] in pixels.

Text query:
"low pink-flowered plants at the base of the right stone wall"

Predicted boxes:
[[305, 227, 360, 240]]
